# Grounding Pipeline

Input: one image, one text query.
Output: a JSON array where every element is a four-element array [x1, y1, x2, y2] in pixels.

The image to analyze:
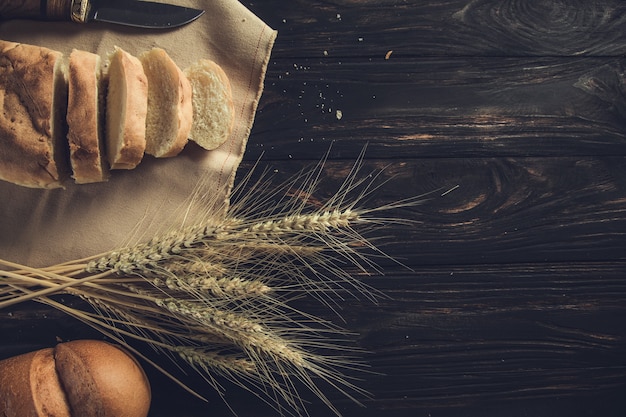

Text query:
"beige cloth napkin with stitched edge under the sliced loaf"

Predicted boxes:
[[0, 0, 277, 266]]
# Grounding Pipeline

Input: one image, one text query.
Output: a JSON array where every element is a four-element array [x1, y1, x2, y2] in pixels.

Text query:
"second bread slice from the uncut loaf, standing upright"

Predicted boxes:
[[106, 47, 148, 169]]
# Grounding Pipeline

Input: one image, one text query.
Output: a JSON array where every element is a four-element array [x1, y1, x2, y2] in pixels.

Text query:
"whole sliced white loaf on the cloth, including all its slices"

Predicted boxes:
[[0, 40, 235, 188]]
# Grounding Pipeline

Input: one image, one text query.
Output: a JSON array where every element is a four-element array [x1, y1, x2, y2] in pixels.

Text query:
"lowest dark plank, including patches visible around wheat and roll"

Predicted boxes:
[[0, 262, 626, 416]]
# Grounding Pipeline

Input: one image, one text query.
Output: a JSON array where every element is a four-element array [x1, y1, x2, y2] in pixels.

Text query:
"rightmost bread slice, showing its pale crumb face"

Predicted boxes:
[[185, 59, 235, 150]]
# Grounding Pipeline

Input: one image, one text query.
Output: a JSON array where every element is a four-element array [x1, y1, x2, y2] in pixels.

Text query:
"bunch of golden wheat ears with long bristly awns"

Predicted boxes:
[[0, 150, 448, 415]]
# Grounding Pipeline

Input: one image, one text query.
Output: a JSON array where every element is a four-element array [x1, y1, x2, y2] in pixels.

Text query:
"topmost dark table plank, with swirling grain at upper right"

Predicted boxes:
[[244, 0, 626, 58]]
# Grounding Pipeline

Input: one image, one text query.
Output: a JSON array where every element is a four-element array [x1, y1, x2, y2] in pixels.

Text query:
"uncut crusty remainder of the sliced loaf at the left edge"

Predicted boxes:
[[0, 41, 68, 188]]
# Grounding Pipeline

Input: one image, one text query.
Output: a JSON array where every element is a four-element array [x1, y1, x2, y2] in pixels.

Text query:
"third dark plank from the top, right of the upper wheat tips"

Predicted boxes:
[[233, 152, 626, 267]]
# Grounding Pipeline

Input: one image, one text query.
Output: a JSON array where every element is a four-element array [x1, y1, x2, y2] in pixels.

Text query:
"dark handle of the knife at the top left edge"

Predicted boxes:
[[0, 0, 79, 20]]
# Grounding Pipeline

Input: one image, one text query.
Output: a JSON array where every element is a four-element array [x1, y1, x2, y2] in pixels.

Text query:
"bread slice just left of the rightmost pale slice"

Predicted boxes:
[[139, 48, 193, 158]]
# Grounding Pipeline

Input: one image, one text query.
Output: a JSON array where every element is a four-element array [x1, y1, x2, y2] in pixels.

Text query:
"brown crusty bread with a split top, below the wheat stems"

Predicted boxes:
[[0, 340, 151, 417]]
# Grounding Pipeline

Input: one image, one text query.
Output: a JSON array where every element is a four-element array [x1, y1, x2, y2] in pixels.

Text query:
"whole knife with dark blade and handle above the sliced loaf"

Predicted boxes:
[[0, 0, 204, 29]]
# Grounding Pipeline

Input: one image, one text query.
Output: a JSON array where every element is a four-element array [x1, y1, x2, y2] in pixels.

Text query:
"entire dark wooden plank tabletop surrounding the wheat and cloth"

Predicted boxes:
[[2, 0, 626, 417]]
